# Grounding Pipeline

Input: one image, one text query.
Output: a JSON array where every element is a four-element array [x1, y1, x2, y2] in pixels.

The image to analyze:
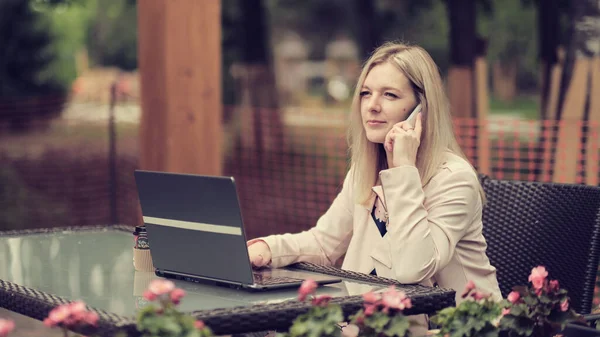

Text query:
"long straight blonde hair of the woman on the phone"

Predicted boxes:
[[348, 42, 484, 204]]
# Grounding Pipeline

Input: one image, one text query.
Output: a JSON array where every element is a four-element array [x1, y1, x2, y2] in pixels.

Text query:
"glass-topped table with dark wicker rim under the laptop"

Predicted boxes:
[[0, 226, 455, 335]]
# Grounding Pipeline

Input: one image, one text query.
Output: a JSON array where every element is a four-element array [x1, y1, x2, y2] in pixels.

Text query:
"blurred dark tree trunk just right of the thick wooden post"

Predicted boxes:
[[234, 0, 283, 158]]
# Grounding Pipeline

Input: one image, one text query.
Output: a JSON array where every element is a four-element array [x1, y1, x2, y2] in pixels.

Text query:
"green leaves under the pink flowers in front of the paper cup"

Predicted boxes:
[[137, 303, 212, 337]]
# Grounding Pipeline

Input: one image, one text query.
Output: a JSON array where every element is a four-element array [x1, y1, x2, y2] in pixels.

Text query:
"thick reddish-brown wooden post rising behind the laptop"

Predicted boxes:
[[138, 0, 223, 175]]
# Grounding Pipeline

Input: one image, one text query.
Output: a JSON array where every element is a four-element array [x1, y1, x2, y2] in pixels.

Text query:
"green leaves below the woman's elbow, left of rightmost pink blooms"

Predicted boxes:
[[431, 290, 503, 337]]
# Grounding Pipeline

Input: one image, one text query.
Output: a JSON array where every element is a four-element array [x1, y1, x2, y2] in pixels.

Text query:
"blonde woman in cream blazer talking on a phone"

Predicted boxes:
[[248, 43, 501, 303]]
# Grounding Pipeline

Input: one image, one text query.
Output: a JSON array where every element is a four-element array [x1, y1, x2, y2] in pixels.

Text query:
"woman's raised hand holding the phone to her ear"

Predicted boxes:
[[384, 113, 422, 167]]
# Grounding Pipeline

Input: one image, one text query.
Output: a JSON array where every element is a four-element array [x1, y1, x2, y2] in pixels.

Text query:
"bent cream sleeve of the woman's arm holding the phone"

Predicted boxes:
[[375, 165, 481, 283]]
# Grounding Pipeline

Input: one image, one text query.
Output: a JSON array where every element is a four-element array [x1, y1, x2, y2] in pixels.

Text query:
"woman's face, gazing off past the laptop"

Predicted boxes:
[[360, 62, 417, 143]]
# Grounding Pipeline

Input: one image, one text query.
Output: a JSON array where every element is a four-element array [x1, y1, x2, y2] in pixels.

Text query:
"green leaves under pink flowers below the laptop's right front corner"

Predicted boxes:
[[278, 304, 344, 337]]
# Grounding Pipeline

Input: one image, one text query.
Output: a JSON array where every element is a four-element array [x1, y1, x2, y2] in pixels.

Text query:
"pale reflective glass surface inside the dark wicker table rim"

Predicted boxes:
[[0, 230, 392, 316]]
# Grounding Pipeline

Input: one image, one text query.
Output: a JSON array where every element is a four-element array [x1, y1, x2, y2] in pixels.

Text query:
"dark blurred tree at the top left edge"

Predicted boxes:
[[0, 0, 66, 132]]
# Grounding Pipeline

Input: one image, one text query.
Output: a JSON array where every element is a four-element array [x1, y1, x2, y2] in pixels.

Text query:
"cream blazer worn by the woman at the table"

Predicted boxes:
[[248, 152, 502, 303]]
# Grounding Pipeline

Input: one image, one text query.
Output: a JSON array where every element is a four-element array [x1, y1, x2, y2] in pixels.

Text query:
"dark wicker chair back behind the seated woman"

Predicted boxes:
[[480, 175, 600, 314]]
